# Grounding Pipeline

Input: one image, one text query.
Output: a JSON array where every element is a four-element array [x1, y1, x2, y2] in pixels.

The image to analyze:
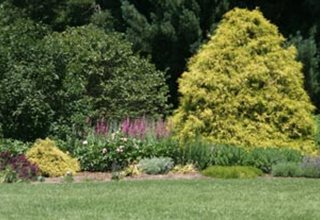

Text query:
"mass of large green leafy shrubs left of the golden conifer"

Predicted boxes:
[[0, 8, 168, 141]]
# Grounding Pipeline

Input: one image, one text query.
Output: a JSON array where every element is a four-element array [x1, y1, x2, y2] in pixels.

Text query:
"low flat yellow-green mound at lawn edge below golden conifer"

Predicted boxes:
[[202, 166, 262, 179]]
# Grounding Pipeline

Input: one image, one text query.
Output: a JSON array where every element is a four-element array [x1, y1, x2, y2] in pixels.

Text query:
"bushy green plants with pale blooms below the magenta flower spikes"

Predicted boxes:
[[70, 130, 179, 171]]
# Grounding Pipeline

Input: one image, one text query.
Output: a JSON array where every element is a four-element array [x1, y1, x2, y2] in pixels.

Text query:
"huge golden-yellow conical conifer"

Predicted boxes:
[[173, 8, 315, 152]]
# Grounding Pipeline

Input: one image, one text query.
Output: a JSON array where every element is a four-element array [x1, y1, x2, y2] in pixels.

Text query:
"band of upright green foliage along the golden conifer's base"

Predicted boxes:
[[178, 139, 303, 173]]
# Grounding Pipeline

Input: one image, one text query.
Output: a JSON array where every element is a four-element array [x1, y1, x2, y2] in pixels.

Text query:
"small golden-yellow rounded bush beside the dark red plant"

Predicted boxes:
[[26, 138, 80, 177]]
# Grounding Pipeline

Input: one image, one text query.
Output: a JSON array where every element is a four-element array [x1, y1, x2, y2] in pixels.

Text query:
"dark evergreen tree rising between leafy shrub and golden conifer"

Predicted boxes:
[[121, 0, 229, 106]]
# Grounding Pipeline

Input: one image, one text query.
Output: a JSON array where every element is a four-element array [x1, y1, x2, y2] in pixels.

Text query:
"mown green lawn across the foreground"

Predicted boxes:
[[0, 178, 320, 220]]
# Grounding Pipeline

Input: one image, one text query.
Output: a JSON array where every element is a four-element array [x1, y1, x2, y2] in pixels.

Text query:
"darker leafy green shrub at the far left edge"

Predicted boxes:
[[0, 3, 52, 140]]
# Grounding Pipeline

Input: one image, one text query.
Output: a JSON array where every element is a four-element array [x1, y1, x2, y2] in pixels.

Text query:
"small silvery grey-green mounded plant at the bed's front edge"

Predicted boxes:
[[138, 157, 174, 174]]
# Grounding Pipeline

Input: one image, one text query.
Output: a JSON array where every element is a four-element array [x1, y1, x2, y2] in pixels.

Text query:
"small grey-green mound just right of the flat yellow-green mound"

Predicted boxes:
[[272, 162, 303, 177]]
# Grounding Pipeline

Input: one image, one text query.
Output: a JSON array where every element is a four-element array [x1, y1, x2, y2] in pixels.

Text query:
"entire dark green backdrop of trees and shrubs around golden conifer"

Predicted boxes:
[[0, 0, 320, 139]]
